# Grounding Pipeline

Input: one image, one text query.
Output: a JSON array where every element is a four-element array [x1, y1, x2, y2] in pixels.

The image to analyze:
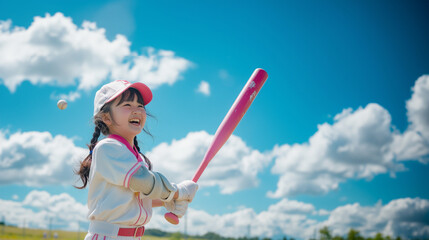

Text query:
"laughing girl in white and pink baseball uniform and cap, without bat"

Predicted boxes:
[[77, 80, 198, 240]]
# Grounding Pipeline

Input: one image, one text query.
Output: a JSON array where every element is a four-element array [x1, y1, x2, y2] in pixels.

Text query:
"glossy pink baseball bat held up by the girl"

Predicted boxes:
[[164, 68, 268, 224]]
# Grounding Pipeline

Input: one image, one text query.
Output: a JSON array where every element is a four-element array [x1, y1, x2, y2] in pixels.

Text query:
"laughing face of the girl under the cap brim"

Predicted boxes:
[[103, 91, 146, 146]]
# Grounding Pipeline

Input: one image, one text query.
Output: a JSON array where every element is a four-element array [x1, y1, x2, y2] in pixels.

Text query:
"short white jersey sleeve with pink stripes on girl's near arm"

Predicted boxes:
[[91, 139, 143, 188]]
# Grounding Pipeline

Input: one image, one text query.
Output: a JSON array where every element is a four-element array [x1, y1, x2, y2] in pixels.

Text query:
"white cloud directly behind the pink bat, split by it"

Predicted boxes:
[[148, 131, 270, 194]]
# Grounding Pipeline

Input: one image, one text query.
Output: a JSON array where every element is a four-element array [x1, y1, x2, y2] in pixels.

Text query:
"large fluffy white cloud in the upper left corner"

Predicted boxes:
[[0, 13, 130, 91]]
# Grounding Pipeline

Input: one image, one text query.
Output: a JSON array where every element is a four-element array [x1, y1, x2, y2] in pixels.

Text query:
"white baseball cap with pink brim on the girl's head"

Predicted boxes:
[[94, 80, 152, 116]]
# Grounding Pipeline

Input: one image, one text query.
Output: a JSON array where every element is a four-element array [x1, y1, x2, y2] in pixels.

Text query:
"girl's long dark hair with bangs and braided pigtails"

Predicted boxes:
[[74, 88, 153, 189]]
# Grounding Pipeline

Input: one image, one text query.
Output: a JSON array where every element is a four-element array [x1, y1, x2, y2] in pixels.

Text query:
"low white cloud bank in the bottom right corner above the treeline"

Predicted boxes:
[[318, 198, 429, 239]]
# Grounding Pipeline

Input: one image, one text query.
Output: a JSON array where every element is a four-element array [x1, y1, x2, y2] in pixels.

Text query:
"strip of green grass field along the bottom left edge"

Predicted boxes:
[[0, 226, 170, 240]]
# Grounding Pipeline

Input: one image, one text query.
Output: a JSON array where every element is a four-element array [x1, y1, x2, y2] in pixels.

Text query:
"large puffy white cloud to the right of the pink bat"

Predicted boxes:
[[269, 104, 404, 197]]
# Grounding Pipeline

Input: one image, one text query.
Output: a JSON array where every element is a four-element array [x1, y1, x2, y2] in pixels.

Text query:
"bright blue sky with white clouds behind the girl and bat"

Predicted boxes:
[[0, 0, 429, 239]]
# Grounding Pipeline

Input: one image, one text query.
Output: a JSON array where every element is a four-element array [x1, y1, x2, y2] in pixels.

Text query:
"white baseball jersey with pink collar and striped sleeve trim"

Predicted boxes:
[[88, 135, 152, 226]]
